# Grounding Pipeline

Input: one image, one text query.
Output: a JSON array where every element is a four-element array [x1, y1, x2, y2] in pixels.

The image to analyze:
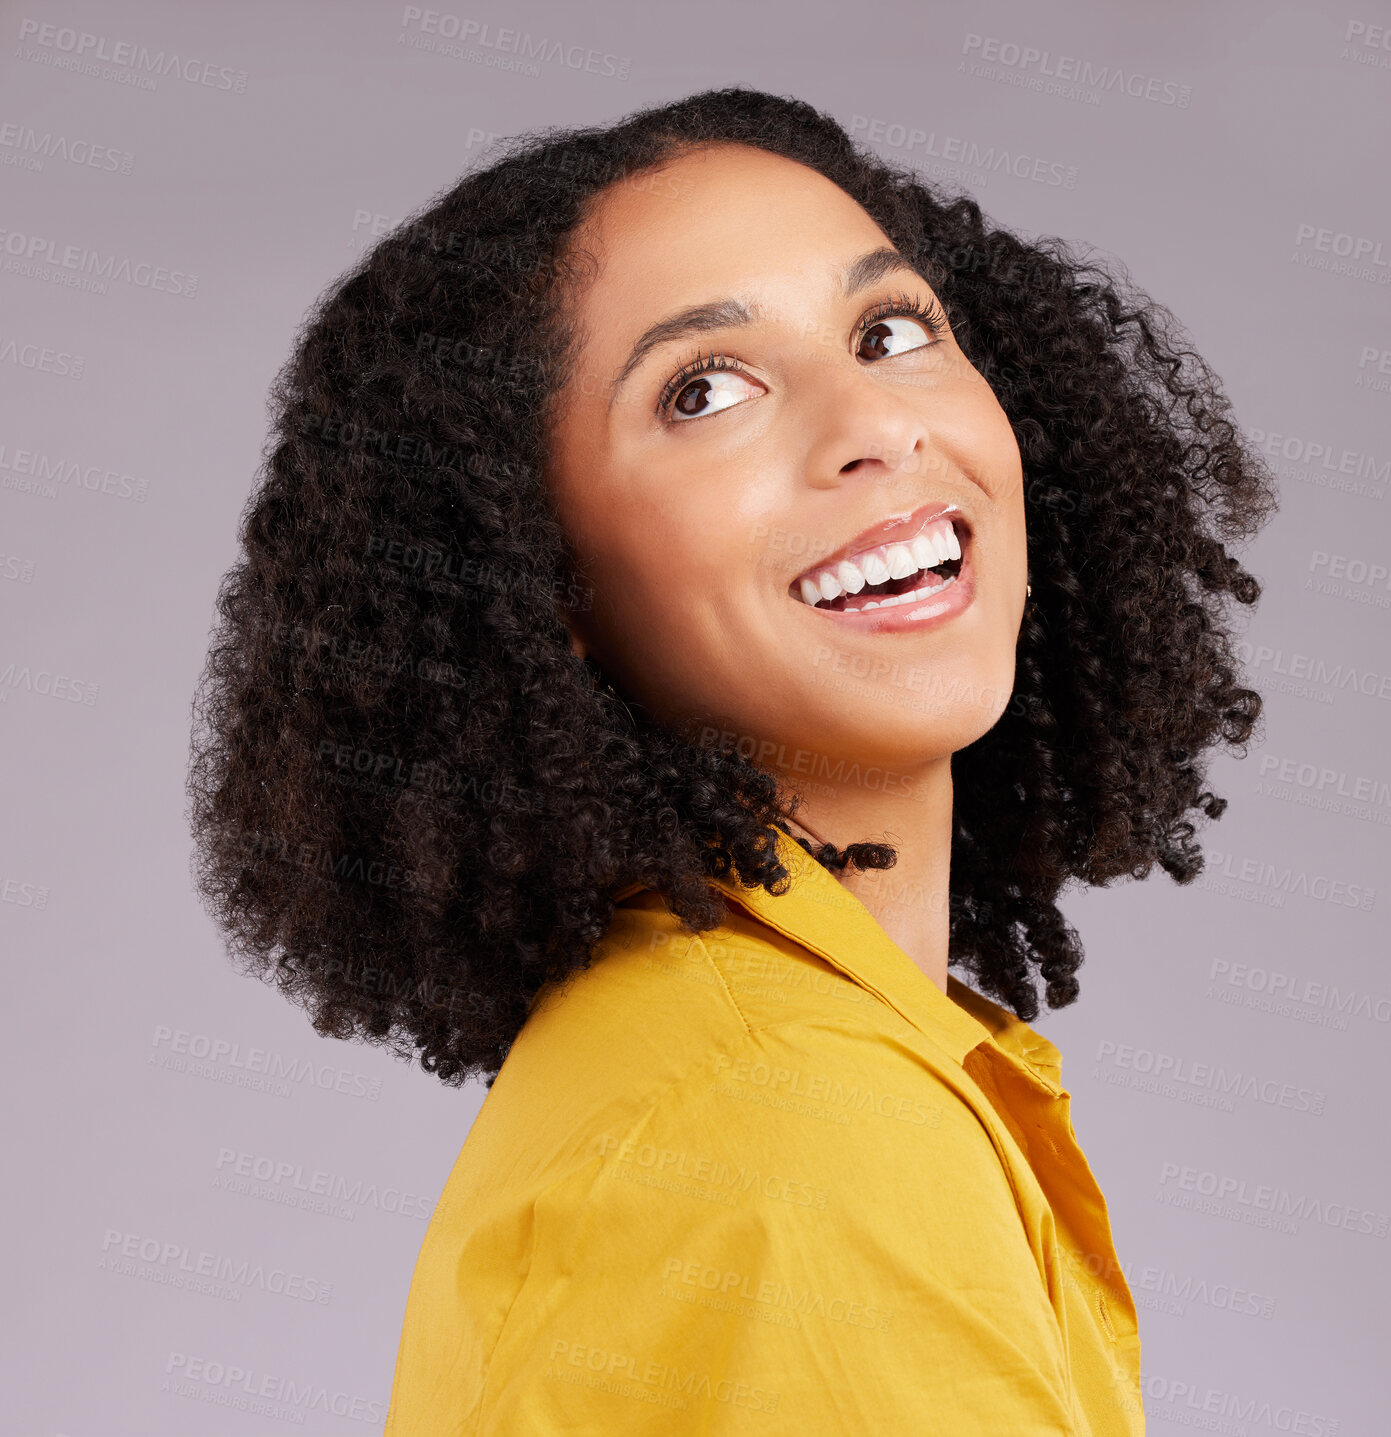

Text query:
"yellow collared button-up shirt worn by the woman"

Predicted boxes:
[[385, 832, 1144, 1437]]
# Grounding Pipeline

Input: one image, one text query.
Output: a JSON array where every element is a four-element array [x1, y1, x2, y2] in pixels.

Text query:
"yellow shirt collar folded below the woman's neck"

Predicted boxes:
[[618, 828, 1062, 1092]]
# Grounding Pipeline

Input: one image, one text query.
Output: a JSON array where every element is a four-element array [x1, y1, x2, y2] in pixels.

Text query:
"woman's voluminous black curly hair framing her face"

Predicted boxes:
[[188, 86, 1276, 1085]]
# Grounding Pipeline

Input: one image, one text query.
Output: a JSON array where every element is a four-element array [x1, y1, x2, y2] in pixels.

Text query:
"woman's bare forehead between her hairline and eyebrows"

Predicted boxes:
[[576, 144, 887, 312]]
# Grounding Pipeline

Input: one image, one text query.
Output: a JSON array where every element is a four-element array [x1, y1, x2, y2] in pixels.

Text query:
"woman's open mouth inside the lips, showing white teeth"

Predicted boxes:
[[792, 514, 970, 614]]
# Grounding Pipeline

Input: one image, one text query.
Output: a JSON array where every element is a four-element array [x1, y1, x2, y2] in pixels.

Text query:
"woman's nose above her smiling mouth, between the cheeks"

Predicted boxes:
[[799, 356, 933, 489]]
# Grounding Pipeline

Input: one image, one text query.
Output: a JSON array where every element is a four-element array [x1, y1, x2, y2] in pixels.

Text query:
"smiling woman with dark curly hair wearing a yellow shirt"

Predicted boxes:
[[190, 88, 1273, 1437]]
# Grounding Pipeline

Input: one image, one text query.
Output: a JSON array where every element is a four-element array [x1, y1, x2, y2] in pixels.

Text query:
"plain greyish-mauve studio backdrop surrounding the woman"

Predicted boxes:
[[0, 0, 1391, 1437]]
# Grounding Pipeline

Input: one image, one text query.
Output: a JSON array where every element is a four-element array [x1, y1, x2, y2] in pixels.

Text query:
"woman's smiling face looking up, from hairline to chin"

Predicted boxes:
[[547, 145, 1026, 777]]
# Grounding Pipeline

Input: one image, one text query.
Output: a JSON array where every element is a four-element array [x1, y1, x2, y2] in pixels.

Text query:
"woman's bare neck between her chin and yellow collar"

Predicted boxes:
[[770, 756, 951, 993]]
